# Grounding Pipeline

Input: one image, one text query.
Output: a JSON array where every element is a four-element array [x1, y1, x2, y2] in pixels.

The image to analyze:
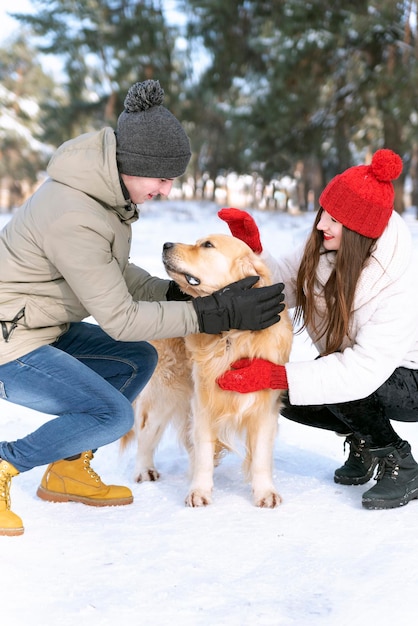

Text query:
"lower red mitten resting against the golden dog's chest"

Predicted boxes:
[[217, 359, 289, 393]]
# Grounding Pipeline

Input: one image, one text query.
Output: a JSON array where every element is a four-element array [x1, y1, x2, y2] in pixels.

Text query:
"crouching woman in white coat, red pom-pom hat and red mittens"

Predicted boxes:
[[219, 149, 418, 509]]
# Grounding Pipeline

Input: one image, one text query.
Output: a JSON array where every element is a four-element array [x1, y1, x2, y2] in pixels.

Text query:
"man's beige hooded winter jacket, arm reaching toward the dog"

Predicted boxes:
[[0, 128, 199, 364]]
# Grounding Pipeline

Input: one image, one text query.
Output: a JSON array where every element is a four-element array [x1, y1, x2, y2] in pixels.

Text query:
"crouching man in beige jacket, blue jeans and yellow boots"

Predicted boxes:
[[0, 80, 283, 535]]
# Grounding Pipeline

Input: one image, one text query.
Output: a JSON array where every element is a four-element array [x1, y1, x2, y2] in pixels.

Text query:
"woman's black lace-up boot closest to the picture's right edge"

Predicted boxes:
[[362, 441, 418, 509]]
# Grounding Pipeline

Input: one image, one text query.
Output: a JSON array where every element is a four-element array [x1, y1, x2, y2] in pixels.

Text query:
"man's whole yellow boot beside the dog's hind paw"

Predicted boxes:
[[36, 450, 133, 506]]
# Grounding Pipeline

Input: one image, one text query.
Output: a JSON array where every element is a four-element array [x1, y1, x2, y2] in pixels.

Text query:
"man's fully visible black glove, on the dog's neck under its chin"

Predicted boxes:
[[192, 276, 285, 335]]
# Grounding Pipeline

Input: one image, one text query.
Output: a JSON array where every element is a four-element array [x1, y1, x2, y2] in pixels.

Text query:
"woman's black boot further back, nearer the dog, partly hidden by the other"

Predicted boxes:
[[334, 435, 378, 485]]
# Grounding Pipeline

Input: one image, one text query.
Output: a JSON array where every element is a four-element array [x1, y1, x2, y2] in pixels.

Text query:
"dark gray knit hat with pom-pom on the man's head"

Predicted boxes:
[[116, 80, 191, 178]]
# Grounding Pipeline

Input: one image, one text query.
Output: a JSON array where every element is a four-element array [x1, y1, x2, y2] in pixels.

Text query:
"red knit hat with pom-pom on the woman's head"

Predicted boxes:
[[319, 149, 402, 239]]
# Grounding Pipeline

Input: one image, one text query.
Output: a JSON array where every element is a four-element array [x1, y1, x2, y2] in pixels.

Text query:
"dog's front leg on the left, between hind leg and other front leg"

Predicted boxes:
[[185, 408, 216, 507]]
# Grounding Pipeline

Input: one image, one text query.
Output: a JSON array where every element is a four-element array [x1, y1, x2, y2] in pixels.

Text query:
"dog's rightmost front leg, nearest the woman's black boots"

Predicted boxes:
[[247, 412, 282, 509]]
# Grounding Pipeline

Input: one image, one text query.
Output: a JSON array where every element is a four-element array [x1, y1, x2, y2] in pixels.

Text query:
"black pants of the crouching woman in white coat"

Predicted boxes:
[[281, 367, 418, 448]]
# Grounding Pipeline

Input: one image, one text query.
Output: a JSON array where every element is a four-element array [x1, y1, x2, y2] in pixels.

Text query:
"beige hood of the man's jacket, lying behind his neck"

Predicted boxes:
[[47, 127, 137, 221]]
